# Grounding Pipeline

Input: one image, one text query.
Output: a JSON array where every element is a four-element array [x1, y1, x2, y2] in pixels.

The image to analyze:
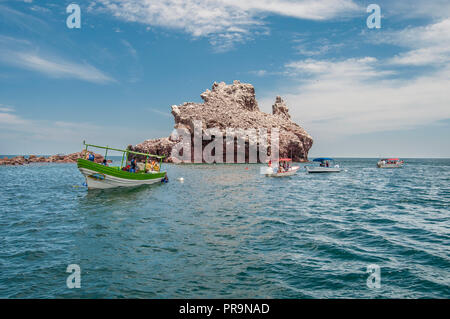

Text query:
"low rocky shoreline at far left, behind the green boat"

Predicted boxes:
[[0, 150, 104, 166]]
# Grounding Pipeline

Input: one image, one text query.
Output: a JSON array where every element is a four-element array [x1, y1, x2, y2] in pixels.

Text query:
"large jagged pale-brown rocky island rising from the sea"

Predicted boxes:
[[128, 81, 313, 162]]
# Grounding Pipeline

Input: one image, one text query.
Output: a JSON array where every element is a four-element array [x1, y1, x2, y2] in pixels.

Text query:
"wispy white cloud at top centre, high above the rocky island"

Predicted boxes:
[[91, 0, 359, 49]]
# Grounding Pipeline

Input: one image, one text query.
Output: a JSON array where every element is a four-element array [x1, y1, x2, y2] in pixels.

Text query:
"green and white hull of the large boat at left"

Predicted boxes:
[[78, 159, 165, 189]]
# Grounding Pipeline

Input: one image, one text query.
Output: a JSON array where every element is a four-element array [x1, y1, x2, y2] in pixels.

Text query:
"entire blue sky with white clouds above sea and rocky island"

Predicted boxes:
[[0, 0, 450, 157]]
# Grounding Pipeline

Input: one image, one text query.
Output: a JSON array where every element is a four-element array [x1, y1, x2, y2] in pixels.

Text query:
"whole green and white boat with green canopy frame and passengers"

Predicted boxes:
[[77, 142, 166, 189]]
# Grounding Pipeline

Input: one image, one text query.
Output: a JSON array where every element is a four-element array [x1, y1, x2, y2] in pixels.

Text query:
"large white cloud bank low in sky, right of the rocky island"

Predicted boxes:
[[261, 57, 450, 138]]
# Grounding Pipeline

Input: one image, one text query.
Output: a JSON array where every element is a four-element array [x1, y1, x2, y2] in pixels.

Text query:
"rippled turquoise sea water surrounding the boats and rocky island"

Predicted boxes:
[[0, 159, 450, 298]]
